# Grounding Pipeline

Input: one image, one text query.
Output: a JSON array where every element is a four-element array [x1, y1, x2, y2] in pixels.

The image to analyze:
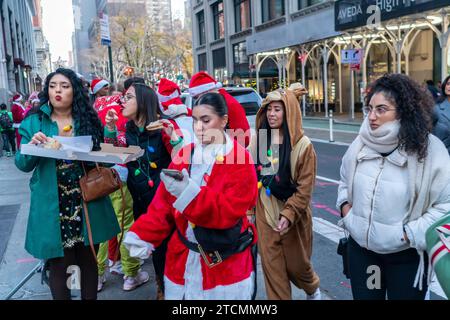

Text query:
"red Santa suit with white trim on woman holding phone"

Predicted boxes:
[[124, 136, 257, 300]]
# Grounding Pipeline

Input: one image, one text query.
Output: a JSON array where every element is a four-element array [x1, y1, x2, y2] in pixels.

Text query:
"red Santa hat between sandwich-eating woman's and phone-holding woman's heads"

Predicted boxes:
[[157, 78, 189, 116]]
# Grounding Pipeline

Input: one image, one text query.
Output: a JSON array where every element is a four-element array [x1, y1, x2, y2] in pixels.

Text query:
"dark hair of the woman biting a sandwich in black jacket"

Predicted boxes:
[[127, 82, 161, 129]]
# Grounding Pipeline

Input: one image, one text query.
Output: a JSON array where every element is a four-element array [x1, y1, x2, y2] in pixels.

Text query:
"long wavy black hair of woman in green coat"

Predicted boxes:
[[28, 68, 103, 150]]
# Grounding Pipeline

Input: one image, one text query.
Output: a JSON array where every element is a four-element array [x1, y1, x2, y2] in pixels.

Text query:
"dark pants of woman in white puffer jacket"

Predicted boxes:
[[348, 237, 428, 300]]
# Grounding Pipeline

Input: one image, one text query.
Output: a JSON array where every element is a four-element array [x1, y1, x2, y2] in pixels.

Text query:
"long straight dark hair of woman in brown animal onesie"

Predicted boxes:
[[257, 100, 293, 186]]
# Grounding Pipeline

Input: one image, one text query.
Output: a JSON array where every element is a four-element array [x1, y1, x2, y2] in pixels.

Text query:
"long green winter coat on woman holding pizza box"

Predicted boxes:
[[15, 105, 120, 259]]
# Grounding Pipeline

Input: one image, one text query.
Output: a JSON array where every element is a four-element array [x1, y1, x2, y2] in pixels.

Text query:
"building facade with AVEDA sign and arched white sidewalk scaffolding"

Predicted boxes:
[[191, 0, 450, 117]]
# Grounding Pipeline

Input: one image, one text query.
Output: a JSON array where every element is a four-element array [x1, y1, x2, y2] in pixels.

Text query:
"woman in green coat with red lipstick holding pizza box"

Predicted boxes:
[[16, 68, 120, 300]]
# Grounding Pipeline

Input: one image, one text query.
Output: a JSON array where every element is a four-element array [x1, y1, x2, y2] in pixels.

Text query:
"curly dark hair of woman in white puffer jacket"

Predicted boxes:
[[366, 74, 434, 161]]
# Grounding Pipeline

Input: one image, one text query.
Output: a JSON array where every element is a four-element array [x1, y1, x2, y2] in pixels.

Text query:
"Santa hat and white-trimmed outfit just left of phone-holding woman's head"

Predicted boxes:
[[158, 78, 195, 145]]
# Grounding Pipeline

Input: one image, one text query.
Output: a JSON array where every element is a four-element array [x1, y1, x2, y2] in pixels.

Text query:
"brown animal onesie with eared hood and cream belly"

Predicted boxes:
[[256, 86, 320, 300]]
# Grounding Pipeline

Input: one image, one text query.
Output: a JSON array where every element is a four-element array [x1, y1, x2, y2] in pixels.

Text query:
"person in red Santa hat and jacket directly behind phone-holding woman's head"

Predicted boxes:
[[189, 71, 251, 147]]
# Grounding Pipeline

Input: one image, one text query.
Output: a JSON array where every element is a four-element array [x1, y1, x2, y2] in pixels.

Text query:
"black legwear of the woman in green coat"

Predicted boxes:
[[48, 244, 98, 300]]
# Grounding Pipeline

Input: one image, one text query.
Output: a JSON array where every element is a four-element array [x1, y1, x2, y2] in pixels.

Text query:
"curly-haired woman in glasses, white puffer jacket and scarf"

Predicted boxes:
[[337, 74, 450, 300]]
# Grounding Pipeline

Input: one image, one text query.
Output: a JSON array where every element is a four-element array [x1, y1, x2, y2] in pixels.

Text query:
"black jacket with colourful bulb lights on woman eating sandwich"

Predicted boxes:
[[126, 121, 171, 214]]
